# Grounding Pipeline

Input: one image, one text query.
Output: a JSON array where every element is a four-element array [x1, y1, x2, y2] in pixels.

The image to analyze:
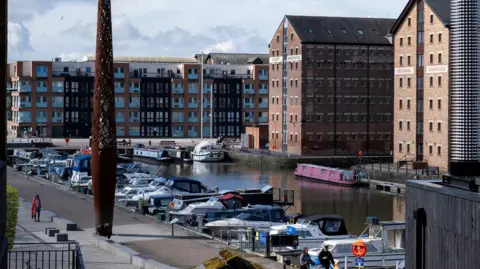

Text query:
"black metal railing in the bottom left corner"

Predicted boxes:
[[6, 241, 85, 269]]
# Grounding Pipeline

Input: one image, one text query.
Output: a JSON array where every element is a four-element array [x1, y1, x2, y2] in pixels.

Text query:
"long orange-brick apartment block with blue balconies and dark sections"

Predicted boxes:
[[8, 52, 268, 138]]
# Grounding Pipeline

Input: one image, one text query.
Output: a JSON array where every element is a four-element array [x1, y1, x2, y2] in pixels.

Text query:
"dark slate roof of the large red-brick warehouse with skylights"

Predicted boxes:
[[285, 15, 395, 45]]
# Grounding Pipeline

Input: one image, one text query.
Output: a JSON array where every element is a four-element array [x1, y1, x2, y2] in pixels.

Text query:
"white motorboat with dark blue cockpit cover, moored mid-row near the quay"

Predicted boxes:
[[205, 205, 286, 237]]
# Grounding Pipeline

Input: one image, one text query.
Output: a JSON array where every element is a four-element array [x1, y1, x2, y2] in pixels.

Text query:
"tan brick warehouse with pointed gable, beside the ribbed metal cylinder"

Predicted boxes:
[[390, 0, 450, 170]]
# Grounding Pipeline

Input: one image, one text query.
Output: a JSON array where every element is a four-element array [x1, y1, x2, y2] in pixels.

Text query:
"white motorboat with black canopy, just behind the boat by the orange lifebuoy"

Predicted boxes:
[[270, 215, 356, 249]]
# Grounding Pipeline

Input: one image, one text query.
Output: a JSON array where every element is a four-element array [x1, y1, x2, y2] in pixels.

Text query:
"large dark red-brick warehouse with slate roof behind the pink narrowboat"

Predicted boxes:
[[269, 16, 395, 155]]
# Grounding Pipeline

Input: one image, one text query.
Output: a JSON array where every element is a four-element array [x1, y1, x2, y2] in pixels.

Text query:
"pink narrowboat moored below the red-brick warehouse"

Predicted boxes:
[[295, 163, 359, 186]]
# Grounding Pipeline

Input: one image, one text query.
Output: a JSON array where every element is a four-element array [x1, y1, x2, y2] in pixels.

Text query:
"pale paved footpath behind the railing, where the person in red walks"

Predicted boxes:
[[12, 201, 141, 269]]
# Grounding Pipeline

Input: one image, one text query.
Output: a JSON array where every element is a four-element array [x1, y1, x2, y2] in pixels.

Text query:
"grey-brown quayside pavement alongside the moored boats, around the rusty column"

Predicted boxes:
[[7, 169, 262, 268]]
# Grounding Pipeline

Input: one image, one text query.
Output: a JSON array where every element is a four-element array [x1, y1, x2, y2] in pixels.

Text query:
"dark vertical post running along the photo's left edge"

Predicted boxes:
[[0, 0, 8, 268]]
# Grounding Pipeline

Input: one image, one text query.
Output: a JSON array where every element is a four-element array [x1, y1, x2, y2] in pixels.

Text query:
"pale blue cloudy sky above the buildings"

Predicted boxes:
[[8, 0, 407, 61]]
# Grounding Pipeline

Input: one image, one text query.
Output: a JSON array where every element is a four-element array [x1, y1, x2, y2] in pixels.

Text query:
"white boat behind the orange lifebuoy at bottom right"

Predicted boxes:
[[308, 218, 405, 268]]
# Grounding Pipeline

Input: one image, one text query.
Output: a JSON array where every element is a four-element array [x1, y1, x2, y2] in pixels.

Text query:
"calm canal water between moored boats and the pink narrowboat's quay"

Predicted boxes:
[[144, 162, 405, 234]]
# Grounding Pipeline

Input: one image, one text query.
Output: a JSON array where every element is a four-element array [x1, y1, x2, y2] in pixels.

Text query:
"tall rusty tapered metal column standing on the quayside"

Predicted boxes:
[[92, 0, 117, 237]]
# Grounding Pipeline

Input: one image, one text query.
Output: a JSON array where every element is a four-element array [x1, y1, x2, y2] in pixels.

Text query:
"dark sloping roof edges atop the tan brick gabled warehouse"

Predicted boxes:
[[390, 0, 450, 34]]
